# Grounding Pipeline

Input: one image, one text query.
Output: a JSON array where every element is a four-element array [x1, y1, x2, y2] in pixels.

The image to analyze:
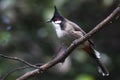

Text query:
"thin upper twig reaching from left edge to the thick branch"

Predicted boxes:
[[0, 54, 39, 69]]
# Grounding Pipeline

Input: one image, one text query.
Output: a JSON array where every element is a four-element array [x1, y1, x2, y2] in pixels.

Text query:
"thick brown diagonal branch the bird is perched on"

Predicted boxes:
[[16, 4, 120, 80]]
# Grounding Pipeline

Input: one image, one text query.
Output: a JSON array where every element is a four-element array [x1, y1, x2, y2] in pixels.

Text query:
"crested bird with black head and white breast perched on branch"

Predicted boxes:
[[48, 6, 109, 76]]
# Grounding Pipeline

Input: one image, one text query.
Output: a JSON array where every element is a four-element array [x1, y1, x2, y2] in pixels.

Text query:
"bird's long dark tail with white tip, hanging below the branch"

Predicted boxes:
[[90, 49, 109, 76]]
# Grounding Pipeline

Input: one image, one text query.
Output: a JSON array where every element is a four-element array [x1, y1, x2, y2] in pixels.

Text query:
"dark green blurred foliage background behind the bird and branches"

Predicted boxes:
[[0, 0, 120, 80]]
